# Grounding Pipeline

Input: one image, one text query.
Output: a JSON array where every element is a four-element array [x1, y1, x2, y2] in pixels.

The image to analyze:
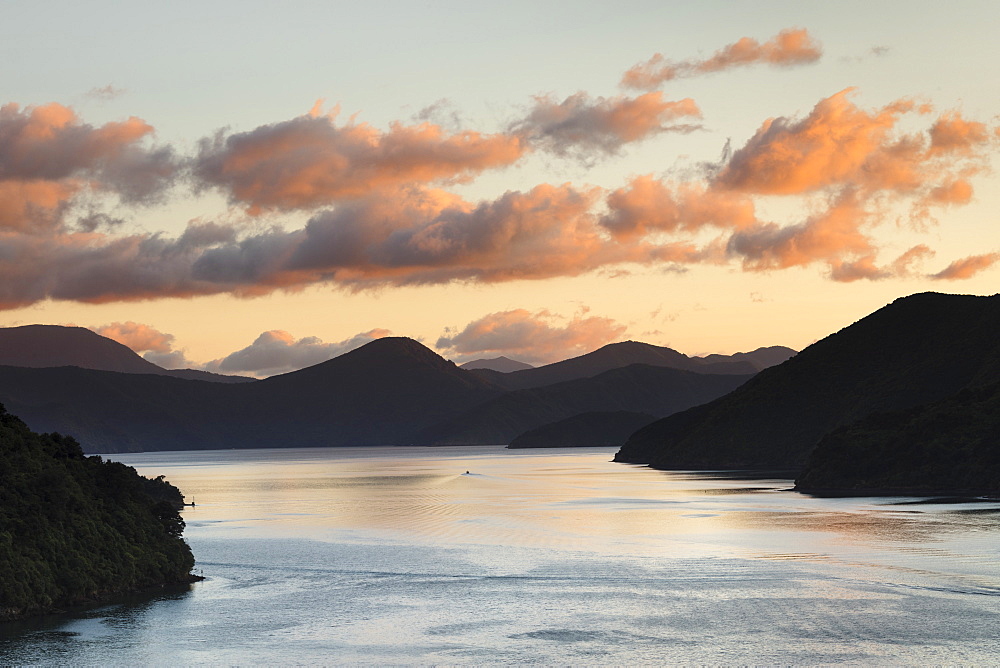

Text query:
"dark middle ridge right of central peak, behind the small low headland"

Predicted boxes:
[[412, 364, 750, 445]]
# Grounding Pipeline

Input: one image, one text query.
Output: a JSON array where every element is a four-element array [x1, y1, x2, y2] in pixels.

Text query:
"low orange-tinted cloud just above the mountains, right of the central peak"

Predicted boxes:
[[435, 309, 625, 364]]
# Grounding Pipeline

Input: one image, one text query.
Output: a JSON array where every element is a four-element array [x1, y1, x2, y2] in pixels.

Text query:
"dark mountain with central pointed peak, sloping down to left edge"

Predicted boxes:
[[0, 338, 501, 452]]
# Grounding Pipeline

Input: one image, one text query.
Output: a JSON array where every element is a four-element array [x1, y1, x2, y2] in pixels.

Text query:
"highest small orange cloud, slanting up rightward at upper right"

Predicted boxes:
[[621, 28, 823, 90]]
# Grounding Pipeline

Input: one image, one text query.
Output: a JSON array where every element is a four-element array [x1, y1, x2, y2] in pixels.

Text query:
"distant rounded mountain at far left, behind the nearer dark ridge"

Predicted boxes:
[[0, 325, 255, 383]]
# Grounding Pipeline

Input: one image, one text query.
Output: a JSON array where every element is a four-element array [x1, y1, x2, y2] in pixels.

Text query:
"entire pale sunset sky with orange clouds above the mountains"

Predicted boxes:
[[0, 0, 1000, 376]]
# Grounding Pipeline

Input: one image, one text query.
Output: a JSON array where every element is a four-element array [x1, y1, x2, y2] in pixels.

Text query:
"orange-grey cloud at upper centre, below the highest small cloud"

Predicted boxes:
[[511, 92, 701, 157]]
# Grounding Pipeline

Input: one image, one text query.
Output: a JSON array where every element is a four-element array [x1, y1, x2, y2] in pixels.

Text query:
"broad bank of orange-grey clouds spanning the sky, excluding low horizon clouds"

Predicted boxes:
[[0, 29, 1000, 314]]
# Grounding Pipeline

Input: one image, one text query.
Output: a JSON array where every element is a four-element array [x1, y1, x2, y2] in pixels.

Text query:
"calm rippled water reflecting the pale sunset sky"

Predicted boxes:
[[0, 448, 1000, 665]]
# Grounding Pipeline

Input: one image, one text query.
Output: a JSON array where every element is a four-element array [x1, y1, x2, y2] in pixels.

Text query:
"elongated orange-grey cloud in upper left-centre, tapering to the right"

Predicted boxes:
[[194, 109, 526, 214]]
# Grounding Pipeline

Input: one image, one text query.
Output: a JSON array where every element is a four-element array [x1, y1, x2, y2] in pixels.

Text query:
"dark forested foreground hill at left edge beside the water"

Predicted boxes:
[[0, 406, 194, 620]]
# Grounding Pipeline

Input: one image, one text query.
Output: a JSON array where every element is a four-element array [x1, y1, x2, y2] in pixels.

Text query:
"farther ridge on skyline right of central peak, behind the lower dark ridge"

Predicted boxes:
[[464, 341, 795, 390]]
